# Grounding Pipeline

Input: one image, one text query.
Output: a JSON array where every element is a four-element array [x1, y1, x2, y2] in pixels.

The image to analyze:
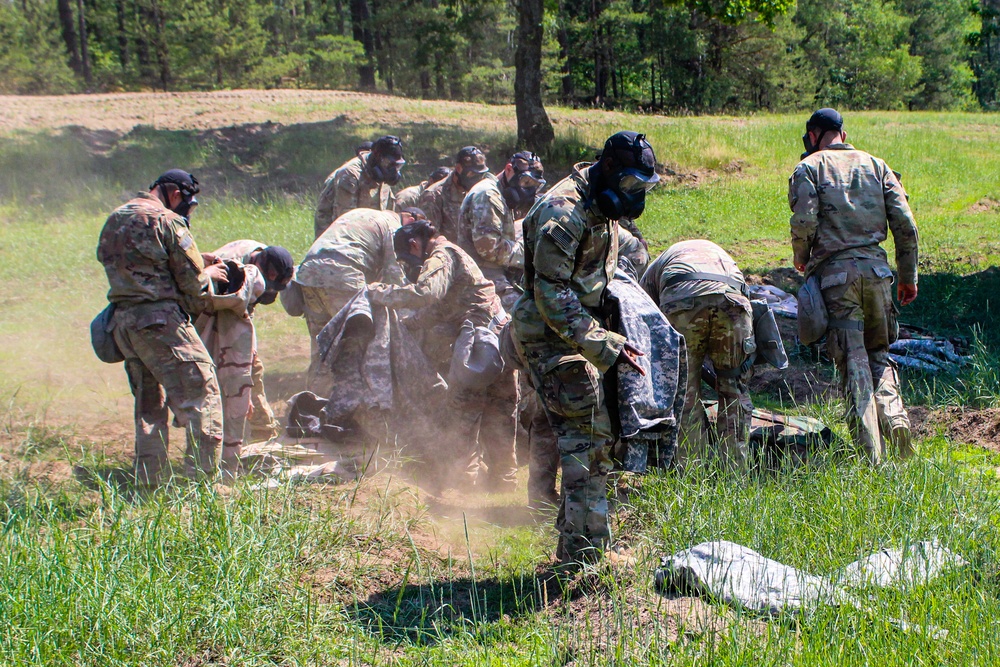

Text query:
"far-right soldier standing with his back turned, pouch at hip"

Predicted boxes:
[[788, 109, 917, 463]]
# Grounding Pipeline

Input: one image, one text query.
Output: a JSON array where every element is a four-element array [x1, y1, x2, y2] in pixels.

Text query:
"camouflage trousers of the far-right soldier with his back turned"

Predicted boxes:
[[819, 259, 913, 463]]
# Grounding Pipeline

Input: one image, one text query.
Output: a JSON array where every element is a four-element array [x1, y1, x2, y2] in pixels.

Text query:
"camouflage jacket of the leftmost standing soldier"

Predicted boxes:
[[97, 192, 210, 315]]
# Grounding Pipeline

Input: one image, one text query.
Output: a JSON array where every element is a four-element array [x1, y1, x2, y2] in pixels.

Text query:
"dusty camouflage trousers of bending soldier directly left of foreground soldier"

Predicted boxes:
[[448, 369, 518, 490]]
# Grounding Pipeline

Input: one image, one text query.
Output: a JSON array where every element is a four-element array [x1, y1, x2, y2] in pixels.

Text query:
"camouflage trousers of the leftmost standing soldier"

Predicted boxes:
[[114, 302, 222, 484]]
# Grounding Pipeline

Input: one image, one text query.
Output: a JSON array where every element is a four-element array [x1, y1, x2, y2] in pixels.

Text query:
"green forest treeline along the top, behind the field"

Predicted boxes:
[[0, 0, 1000, 113]]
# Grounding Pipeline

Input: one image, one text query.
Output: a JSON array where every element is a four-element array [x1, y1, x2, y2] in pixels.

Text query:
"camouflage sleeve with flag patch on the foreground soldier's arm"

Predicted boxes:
[[534, 215, 625, 372]]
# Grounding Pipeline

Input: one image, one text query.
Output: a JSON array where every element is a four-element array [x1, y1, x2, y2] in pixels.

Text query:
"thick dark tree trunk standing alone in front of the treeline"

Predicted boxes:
[[514, 0, 555, 153]]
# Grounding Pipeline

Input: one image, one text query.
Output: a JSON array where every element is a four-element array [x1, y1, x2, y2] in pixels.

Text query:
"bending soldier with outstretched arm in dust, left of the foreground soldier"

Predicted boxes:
[[368, 221, 517, 491]]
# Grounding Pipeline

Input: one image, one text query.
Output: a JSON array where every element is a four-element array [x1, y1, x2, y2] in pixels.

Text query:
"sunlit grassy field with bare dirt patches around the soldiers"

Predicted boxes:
[[0, 91, 1000, 667]]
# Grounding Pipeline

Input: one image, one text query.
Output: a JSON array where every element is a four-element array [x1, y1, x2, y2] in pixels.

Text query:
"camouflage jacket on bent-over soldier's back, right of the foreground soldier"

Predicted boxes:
[[640, 239, 746, 308]]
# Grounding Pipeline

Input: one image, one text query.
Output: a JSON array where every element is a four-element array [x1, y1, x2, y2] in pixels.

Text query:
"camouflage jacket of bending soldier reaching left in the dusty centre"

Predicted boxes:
[[369, 236, 503, 361]]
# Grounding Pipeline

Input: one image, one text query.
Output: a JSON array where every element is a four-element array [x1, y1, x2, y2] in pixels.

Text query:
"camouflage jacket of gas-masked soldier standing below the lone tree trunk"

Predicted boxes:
[[457, 178, 524, 269]]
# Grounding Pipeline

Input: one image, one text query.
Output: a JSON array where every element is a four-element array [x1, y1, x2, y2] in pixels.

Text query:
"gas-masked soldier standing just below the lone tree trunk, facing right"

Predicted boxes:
[[456, 151, 545, 309]]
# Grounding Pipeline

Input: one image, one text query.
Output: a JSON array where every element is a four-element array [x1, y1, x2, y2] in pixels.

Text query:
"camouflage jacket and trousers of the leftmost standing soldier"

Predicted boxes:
[[97, 193, 222, 483]]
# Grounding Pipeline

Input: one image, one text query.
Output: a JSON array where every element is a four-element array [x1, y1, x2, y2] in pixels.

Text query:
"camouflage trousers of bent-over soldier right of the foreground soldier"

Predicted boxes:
[[664, 293, 753, 470]]
